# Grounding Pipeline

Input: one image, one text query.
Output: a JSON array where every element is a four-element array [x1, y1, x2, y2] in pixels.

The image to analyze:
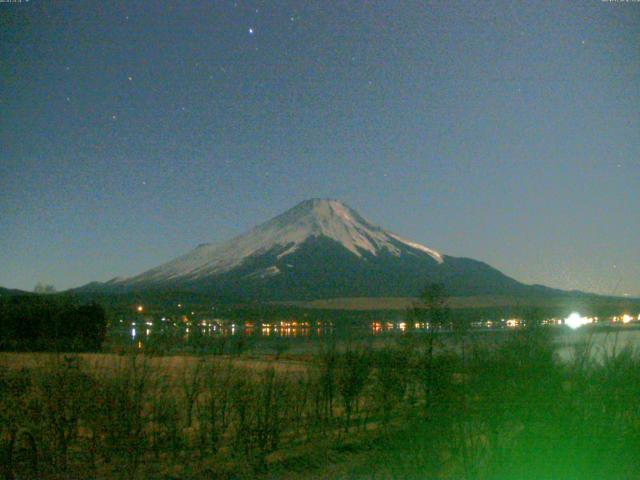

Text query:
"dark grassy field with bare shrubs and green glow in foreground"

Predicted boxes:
[[0, 330, 640, 480]]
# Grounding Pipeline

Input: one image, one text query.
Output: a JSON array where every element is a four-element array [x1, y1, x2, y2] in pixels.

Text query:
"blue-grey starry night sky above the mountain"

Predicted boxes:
[[0, 0, 640, 296]]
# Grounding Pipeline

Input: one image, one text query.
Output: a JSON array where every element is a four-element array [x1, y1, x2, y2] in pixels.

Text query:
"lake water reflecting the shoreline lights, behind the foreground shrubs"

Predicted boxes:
[[116, 320, 640, 362]]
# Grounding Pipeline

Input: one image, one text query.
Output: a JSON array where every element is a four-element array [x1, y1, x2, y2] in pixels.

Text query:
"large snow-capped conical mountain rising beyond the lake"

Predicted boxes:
[[80, 199, 559, 300]]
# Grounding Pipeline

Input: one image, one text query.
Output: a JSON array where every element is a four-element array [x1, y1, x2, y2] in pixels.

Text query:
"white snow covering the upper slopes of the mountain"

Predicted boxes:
[[115, 199, 443, 284]]
